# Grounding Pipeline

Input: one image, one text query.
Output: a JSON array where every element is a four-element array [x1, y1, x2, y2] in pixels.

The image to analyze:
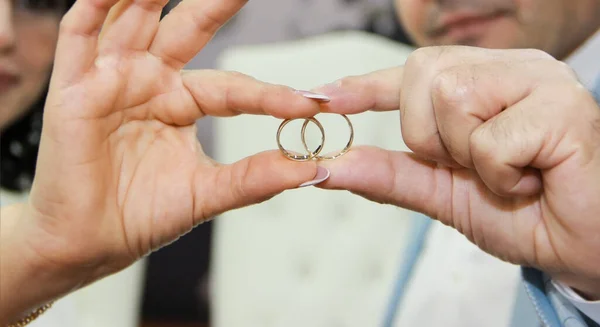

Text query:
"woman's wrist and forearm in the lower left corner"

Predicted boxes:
[[0, 204, 86, 326]]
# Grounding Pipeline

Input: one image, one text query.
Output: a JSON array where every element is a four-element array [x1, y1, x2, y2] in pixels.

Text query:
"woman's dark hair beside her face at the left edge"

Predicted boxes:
[[0, 0, 75, 192]]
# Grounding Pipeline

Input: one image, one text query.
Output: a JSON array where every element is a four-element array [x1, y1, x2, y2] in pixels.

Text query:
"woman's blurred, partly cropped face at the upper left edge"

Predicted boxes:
[[0, 0, 64, 131]]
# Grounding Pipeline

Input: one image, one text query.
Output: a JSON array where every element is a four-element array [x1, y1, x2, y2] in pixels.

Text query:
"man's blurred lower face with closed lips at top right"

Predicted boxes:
[[395, 0, 600, 59]]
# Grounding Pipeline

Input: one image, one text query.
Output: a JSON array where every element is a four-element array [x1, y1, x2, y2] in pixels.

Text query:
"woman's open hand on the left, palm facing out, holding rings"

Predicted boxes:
[[25, 0, 318, 269]]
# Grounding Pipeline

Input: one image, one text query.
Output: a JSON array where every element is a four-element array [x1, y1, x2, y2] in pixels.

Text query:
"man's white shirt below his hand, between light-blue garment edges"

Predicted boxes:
[[395, 222, 521, 327]]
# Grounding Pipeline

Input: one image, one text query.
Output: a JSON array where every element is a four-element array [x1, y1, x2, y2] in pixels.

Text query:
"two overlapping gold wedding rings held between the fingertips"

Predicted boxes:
[[277, 114, 354, 161]]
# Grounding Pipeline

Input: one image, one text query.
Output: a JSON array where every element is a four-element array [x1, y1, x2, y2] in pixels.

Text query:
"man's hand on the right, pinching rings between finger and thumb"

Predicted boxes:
[[317, 47, 600, 298]]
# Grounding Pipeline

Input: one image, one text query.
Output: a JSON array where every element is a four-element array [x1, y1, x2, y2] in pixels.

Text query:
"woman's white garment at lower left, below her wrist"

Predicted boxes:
[[0, 190, 146, 327]]
